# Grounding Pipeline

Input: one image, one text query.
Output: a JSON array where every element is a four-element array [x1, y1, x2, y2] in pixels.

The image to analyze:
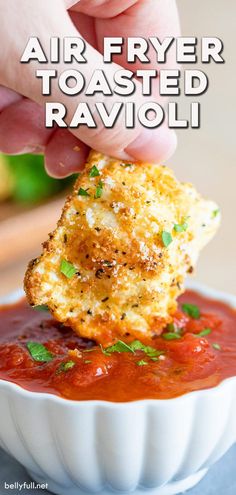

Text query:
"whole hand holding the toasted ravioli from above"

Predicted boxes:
[[0, 0, 179, 177]]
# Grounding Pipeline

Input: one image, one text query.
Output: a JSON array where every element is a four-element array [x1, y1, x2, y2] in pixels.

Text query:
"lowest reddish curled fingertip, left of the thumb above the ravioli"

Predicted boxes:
[[45, 129, 89, 178]]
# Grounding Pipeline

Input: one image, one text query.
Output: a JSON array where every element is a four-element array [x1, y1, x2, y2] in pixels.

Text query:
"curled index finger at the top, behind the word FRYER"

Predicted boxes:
[[71, 0, 180, 71]]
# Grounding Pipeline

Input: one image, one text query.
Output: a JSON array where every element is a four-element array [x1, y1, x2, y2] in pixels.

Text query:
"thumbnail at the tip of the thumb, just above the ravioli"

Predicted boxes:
[[124, 125, 177, 163]]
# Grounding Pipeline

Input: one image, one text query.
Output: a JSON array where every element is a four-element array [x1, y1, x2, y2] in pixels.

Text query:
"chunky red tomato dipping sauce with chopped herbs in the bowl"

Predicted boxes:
[[0, 291, 236, 402]]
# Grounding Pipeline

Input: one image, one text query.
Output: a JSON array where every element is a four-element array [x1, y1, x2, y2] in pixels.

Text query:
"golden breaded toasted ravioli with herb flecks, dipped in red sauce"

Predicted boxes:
[[25, 151, 220, 342]]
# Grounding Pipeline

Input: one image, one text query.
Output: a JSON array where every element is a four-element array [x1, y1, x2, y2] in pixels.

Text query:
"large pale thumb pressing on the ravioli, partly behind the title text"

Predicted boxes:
[[1, 0, 176, 162]]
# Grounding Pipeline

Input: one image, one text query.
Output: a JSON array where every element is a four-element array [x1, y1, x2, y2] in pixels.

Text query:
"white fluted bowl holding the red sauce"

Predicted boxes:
[[0, 284, 236, 495]]
